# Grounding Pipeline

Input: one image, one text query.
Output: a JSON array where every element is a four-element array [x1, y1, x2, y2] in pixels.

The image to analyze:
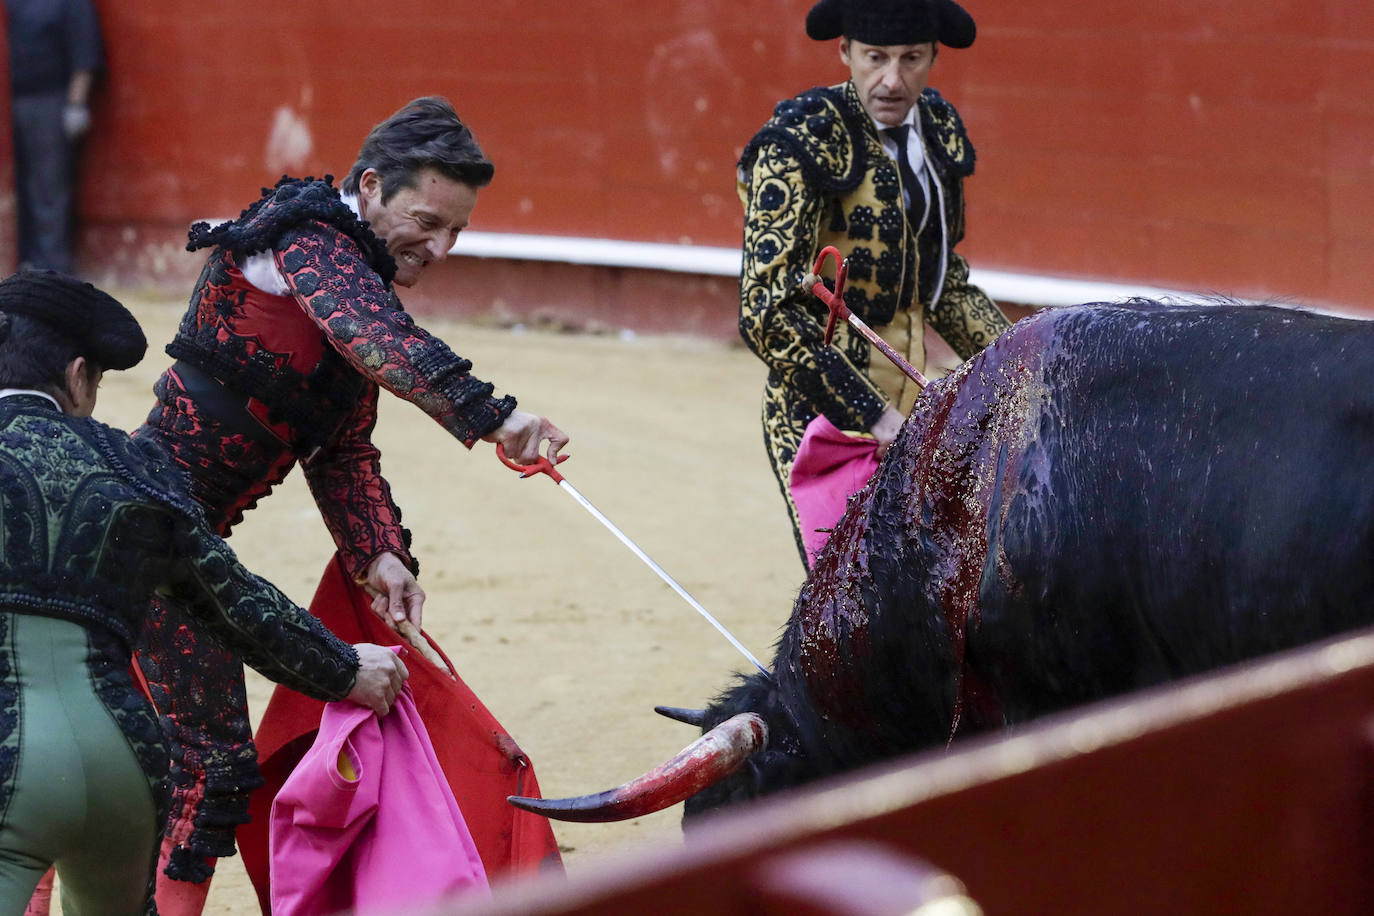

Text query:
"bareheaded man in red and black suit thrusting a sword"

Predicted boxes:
[[135, 98, 567, 915]]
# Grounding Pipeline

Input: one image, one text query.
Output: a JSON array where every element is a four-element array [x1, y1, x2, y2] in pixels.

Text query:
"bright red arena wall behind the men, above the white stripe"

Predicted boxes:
[[48, 0, 1374, 314]]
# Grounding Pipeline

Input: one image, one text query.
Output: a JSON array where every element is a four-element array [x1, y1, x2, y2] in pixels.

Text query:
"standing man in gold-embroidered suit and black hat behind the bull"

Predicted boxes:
[[739, 0, 1009, 563]]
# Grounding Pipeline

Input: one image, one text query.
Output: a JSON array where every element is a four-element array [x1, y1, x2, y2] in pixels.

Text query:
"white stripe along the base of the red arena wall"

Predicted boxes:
[[449, 231, 1201, 305]]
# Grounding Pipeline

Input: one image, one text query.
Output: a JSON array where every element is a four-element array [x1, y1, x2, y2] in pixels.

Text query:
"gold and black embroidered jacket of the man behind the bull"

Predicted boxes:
[[739, 82, 1007, 447]]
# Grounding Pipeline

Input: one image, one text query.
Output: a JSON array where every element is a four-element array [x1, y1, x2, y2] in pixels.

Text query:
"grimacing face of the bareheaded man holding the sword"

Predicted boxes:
[[357, 169, 477, 286]]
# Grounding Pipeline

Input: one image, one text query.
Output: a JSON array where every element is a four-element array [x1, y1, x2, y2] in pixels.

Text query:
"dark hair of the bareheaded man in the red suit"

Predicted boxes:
[[342, 96, 496, 203]]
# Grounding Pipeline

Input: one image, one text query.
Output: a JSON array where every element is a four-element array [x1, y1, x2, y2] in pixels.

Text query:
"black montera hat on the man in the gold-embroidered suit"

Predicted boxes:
[[807, 0, 977, 48]]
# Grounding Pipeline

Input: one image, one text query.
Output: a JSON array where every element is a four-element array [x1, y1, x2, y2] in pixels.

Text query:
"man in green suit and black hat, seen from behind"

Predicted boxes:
[[0, 271, 407, 915]]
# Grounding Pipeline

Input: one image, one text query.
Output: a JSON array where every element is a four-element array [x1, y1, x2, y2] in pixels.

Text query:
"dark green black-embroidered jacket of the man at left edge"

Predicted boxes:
[[0, 394, 357, 700]]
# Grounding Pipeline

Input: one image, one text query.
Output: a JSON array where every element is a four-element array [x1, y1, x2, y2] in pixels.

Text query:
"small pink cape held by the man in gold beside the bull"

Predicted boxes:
[[787, 416, 878, 566]]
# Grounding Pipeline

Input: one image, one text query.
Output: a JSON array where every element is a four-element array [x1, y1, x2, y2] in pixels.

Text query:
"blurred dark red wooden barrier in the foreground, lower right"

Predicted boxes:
[[451, 632, 1374, 916]]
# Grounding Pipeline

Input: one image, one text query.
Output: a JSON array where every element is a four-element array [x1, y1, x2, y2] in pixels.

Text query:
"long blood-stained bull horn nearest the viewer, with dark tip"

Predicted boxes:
[[506, 713, 768, 824]]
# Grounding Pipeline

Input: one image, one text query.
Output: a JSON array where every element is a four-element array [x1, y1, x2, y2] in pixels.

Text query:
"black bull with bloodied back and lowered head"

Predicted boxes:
[[513, 302, 1374, 820]]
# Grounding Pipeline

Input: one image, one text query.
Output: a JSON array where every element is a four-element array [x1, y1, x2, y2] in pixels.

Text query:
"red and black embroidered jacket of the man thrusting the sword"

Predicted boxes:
[[139, 179, 515, 575]]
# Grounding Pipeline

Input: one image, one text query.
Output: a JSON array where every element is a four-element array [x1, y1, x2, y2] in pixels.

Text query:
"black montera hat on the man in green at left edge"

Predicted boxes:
[[0, 271, 148, 369]]
